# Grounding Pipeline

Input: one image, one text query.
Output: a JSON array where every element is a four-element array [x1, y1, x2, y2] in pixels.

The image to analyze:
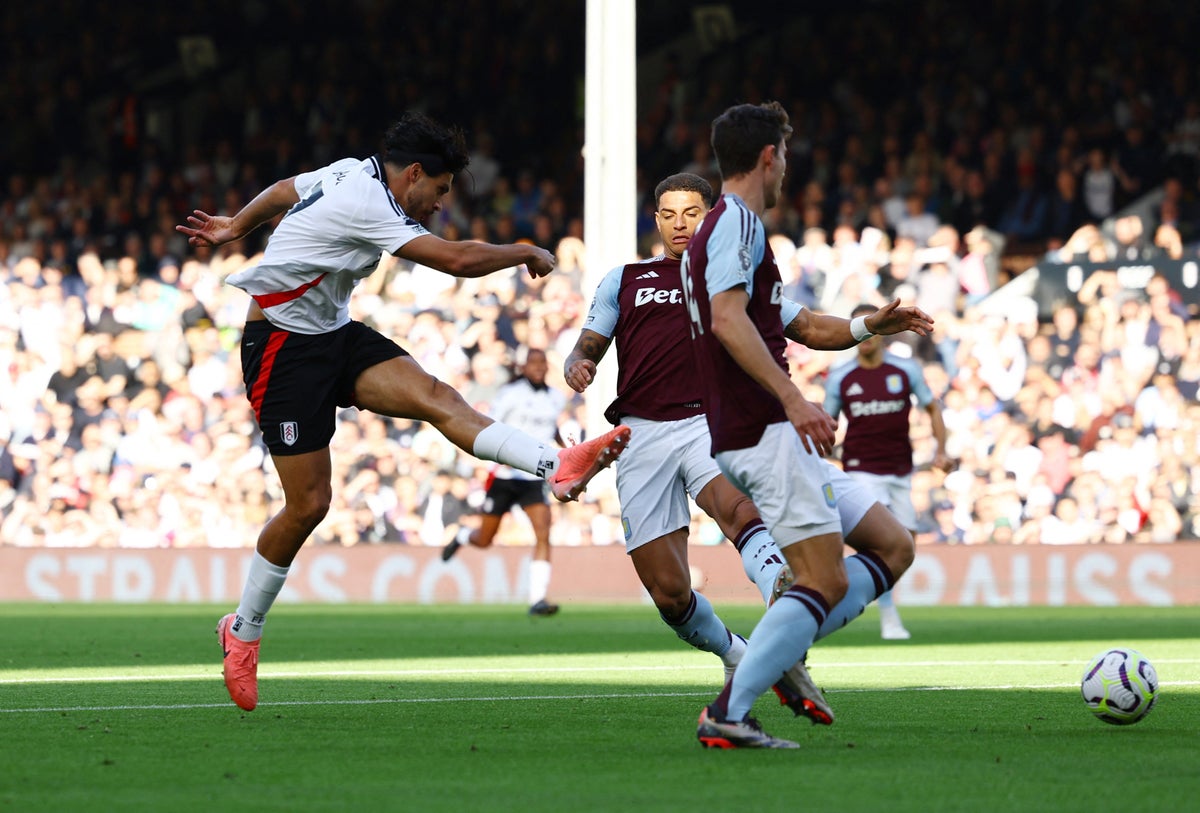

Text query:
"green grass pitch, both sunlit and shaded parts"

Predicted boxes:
[[0, 604, 1200, 813]]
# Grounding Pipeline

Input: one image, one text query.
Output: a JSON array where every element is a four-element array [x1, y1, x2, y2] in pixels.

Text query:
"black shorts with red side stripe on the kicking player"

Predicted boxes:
[[241, 319, 408, 454]]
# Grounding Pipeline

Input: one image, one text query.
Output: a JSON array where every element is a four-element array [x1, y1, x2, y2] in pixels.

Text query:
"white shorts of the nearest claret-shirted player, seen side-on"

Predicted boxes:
[[716, 423, 876, 548]]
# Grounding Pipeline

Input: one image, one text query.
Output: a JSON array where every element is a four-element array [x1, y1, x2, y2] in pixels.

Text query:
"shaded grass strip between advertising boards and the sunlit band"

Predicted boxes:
[[0, 604, 1200, 670]]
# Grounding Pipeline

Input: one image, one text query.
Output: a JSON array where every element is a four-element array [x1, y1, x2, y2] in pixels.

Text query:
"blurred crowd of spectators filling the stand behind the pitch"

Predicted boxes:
[[0, 0, 1200, 547]]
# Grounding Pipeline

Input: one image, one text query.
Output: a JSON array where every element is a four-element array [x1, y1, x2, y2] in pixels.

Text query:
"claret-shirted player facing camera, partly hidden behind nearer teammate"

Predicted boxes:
[[564, 173, 930, 723]]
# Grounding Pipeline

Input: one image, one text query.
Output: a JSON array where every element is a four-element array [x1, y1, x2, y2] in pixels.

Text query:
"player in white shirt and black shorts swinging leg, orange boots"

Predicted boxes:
[[175, 113, 629, 710]]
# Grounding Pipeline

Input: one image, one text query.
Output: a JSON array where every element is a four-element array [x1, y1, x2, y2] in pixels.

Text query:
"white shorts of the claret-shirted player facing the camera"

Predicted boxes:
[[616, 415, 721, 553]]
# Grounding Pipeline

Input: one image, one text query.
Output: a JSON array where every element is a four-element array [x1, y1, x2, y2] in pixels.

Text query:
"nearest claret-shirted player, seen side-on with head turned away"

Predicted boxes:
[[683, 102, 925, 748]]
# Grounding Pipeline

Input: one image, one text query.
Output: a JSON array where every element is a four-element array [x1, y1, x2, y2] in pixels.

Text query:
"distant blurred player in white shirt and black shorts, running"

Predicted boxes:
[[442, 348, 566, 615]]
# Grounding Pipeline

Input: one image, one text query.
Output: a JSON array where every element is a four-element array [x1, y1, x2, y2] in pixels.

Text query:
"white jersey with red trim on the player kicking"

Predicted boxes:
[[226, 155, 428, 335]]
